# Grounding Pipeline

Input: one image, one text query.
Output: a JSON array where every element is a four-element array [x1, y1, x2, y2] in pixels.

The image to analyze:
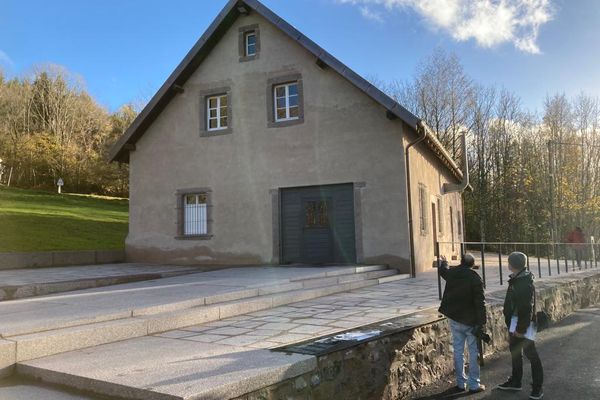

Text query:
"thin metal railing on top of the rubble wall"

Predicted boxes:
[[435, 242, 600, 300]]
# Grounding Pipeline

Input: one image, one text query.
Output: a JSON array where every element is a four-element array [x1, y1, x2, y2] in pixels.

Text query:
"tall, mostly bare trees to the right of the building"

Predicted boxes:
[[372, 49, 600, 242]]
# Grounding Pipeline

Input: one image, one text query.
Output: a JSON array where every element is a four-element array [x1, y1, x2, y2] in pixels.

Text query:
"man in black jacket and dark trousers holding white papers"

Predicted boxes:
[[498, 252, 544, 400]]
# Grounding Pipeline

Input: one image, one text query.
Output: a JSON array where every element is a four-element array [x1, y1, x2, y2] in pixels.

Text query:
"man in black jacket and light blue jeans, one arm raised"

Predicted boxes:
[[439, 253, 486, 393]]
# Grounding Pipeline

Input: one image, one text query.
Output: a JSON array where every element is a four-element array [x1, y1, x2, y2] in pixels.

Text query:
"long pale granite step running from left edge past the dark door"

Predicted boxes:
[[0, 269, 395, 369]]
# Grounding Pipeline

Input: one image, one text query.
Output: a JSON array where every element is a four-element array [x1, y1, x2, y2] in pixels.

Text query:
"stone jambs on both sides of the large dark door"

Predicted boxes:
[[269, 182, 367, 264]]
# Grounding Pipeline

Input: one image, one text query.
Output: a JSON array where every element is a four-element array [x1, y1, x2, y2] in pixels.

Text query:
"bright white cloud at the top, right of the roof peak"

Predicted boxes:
[[336, 0, 553, 54]]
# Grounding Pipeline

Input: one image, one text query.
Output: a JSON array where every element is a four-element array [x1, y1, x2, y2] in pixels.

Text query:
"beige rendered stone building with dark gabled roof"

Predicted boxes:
[[111, 0, 463, 274]]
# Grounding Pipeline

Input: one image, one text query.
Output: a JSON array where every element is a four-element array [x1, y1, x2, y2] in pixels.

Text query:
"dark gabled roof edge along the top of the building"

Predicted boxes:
[[110, 0, 462, 178]]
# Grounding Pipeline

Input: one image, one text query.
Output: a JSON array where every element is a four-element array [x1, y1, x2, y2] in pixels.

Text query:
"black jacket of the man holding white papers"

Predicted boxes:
[[503, 269, 535, 334]]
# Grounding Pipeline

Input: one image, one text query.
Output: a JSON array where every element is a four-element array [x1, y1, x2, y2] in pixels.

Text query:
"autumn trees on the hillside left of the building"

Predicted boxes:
[[0, 66, 132, 197]]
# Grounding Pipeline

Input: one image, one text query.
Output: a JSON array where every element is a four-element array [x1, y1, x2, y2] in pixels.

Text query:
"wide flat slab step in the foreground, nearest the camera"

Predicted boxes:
[[17, 336, 316, 400]]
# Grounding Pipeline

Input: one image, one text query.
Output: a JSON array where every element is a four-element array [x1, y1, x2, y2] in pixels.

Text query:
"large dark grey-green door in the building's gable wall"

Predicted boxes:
[[281, 184, 356, 264]]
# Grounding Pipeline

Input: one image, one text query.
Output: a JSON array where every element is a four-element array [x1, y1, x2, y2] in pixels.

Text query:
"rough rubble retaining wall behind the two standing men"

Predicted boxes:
[[236, 271, 600, 400]]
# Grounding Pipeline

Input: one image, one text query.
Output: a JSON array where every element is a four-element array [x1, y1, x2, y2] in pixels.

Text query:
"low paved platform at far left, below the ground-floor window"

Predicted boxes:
[[0, 264, 198, 301]]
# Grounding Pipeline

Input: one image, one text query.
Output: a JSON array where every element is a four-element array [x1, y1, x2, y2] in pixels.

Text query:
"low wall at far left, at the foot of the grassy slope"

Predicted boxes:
[[0, 250, 125, 270]]
